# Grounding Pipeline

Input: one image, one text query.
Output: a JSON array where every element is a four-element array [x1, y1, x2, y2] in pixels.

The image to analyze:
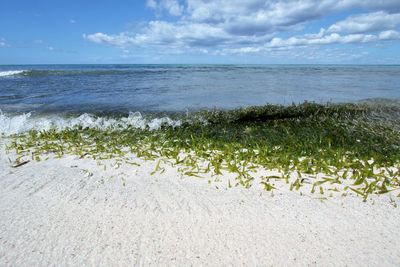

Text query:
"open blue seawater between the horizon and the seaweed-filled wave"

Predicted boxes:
[[0, 65, 400, 114]]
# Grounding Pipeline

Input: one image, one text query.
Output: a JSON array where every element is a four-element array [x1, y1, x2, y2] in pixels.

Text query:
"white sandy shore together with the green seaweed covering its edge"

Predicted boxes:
[[0, 104, 400, 266]]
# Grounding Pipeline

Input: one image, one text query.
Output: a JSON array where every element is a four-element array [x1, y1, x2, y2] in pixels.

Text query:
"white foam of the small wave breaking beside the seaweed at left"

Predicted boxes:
[[0, 110, 181, 135]]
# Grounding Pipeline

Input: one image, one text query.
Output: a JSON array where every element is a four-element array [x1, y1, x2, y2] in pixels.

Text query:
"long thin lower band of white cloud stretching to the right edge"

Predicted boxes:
[[85, 27, 400, 54]]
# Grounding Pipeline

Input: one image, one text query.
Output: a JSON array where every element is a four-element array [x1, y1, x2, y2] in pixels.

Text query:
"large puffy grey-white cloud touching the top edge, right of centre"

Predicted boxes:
[[185, 0, 400, 35]]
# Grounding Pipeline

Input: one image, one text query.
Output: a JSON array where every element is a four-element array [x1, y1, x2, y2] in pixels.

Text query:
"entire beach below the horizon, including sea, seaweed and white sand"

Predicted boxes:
[[0, 65, 400, 266]]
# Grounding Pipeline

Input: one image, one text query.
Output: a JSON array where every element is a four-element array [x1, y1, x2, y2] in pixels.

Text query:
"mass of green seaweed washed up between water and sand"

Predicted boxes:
[[9, 103, 400, 200]]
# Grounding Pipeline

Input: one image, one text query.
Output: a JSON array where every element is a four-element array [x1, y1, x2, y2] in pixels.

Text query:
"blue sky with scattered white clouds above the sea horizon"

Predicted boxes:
[[0, 0, 400, 64]]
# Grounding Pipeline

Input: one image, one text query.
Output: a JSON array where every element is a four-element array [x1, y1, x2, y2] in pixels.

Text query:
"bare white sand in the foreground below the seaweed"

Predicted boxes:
[[0, 144, 400, 266]]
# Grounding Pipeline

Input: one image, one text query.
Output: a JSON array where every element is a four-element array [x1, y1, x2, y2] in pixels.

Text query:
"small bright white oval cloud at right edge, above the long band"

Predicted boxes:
[[328, 11, 400, 33]]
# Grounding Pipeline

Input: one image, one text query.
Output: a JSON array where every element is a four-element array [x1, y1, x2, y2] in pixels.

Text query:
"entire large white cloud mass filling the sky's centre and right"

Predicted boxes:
[[83, 0, 400, 53]]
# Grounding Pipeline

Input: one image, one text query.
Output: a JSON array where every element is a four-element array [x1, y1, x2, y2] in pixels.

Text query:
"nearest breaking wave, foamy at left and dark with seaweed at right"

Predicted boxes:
[[0, 99, 400, 136]]
